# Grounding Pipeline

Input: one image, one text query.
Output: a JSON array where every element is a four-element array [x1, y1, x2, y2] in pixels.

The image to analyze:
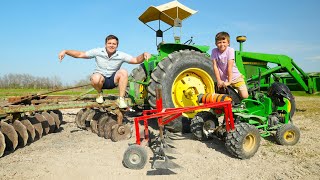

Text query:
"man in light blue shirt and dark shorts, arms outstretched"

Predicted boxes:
[[59, 35, 151, 108]]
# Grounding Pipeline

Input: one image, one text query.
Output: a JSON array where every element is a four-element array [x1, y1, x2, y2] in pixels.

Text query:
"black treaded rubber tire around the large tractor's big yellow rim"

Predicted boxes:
[[147, 50, 215, 132]]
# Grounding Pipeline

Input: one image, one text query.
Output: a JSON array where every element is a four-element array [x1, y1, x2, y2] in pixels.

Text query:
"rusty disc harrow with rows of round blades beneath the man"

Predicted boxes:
[[0, 85, 132, 157]]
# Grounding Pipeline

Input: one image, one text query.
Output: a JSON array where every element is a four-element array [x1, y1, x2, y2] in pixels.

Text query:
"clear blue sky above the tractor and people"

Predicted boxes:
[[0, 0, 320, 84]]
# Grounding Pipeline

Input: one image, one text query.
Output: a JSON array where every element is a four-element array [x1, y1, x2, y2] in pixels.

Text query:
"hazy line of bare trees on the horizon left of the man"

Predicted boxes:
[[0, 73, 89, 89]]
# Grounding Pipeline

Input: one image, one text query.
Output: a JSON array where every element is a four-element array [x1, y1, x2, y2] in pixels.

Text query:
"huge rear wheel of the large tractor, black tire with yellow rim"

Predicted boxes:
[[147, 50, 215, 132]]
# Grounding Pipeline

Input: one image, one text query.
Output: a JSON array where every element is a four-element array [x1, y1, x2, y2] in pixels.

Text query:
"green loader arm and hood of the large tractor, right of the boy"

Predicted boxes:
[[235, 51, 320, 94]]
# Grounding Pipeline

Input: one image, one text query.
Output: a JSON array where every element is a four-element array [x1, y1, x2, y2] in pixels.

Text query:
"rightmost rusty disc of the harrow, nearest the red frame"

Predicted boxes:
[[111, 124, 132, 142]]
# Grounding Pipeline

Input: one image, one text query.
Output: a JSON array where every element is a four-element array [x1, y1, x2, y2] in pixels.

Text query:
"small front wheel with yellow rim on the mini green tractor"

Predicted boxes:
[[276, 123, 300, 146]]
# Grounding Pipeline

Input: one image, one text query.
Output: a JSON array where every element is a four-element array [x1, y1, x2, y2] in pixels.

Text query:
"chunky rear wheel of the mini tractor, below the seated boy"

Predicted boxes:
[[225, 123, 260, 159]]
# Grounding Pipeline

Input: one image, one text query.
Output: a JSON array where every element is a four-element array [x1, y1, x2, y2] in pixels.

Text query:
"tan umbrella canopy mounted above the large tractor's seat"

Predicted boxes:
[[139, 1, 197, 26]]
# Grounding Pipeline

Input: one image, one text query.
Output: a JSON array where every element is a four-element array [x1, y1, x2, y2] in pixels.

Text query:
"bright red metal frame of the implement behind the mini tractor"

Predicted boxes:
[[134, 98, 234, 145]]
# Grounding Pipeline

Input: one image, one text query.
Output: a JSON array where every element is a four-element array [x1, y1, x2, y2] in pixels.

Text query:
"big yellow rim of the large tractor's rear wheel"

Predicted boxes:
[[171, 68, 214, 118]]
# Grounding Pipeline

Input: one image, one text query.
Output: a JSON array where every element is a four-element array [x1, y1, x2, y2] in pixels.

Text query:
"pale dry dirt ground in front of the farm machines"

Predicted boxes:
[[0, 97, 320, 180]]
